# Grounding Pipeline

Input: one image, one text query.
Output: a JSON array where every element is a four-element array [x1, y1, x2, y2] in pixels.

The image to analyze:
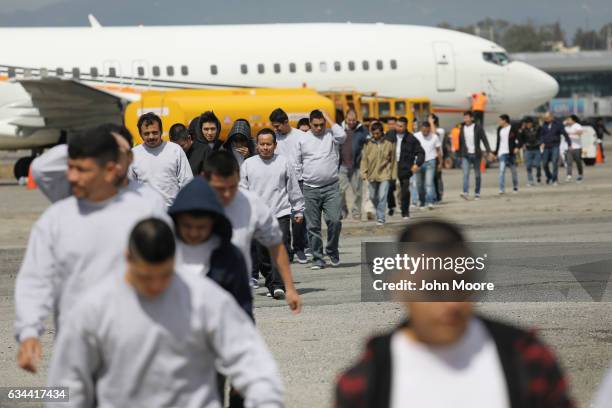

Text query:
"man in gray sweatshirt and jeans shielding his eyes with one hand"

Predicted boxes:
[[297, 110, 346, 269]]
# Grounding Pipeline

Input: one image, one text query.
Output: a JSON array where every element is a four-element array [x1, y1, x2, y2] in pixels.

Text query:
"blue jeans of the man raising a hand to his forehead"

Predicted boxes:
[[304, 181, 342, 261]]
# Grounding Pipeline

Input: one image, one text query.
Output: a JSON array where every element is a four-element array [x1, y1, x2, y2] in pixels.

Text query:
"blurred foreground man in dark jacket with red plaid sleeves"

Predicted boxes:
[[334, 220, 574, 408]]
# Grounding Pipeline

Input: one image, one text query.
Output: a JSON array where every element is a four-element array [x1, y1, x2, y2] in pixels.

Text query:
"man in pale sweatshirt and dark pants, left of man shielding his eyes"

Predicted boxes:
[[240, 128, 304, 299]]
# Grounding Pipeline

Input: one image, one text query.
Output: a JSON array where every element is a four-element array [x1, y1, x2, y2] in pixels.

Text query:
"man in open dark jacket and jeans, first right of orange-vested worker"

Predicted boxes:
[[495, 114, 520, 195]]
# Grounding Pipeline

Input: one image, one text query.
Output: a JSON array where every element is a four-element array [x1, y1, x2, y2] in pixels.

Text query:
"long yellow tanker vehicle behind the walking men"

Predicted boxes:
[[124, 88, 334, 144]]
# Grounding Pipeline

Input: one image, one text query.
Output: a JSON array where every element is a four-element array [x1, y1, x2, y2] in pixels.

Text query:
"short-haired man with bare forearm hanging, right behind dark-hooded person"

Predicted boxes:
[[204, 150, 301, 313]]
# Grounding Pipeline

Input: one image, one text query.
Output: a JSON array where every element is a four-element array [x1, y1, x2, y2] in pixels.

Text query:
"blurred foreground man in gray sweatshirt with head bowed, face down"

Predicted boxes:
[[49, 218, 283, 408]]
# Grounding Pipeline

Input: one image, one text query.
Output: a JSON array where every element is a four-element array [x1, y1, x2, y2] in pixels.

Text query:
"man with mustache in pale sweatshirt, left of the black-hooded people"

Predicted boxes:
[[129, 112, 193, 207]]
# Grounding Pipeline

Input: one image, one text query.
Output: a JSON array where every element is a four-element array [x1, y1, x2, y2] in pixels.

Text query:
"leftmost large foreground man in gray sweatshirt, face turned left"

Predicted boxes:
[[15, 127, 167, 371]]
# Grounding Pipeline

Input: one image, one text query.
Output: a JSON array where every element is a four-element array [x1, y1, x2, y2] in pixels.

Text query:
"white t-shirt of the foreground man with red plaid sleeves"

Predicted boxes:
[[391, 318, 510, 408]]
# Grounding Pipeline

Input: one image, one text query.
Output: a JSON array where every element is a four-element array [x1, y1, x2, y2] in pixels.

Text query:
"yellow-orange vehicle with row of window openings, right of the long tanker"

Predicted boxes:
[[322, 91, 431, 131]]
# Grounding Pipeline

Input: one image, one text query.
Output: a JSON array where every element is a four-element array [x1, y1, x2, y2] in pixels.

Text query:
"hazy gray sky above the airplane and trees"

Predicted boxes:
[[0, 0, 612, 37]]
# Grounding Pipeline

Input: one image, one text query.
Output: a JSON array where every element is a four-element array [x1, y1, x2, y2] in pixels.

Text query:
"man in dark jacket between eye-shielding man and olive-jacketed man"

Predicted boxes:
[[338, 109, 368, 220]]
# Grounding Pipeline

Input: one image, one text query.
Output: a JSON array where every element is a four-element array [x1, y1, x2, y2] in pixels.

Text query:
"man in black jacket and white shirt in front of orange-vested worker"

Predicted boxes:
[[459, 111, 491, 200]]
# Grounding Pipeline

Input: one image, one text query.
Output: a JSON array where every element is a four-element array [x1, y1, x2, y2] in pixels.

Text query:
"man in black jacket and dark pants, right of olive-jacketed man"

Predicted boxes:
[[385, 116, 418, 218]]
